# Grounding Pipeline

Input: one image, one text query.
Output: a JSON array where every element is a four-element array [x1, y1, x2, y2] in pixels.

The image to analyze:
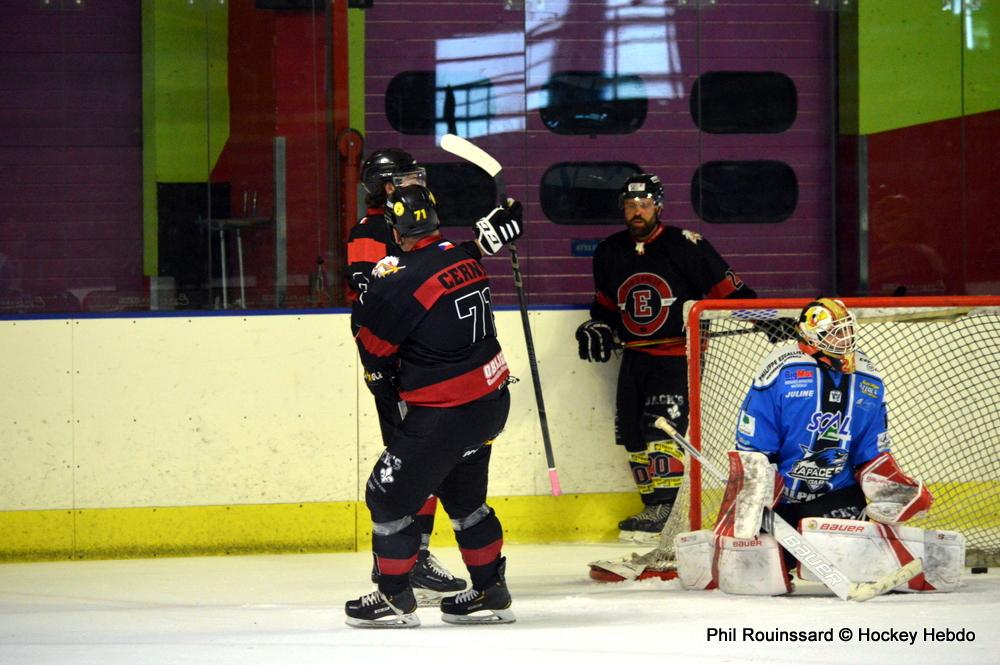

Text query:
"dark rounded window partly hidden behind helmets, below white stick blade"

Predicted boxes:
[[421, 162, 497, 226]]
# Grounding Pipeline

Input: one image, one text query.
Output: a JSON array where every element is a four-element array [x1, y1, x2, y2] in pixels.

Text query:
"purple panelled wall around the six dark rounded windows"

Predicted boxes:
[[365, 0, 833, 304]]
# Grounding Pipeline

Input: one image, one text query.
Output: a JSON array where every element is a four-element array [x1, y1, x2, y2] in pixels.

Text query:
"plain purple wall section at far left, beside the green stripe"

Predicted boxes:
[[0, 0, 145, 312]]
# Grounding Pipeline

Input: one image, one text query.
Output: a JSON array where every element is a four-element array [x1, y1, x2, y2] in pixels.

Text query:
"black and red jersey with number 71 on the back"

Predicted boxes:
[[352, 235, 509, 407]]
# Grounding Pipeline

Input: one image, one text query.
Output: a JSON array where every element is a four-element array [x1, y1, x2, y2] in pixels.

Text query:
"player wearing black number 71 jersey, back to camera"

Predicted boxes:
[[345, 185, 520, 627]]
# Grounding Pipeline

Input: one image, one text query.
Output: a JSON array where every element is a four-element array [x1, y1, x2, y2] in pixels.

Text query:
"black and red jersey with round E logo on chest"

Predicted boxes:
[[590, 225, 756, 355]]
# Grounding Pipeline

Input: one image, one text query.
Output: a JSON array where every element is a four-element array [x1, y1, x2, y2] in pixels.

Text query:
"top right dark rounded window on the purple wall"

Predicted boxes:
[[691, 72, 798, 134]]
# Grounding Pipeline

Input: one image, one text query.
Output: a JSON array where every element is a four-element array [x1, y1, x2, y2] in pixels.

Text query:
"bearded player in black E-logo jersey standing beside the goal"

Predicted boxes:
[[576, 173, 756, 542]]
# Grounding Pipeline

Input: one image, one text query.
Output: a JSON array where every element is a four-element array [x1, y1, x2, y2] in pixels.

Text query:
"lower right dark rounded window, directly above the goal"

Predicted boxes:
[[691, 160, 799, 224]]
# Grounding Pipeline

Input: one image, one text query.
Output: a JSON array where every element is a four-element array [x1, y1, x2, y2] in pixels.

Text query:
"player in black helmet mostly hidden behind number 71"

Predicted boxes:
[[345, 148, 520, 605]]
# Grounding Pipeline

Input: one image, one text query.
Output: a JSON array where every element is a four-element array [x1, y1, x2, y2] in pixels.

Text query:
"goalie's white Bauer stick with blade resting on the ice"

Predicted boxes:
[[653, 417, 924, 602]]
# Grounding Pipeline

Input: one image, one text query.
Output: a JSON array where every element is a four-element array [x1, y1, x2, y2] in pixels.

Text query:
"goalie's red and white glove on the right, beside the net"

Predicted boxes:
[[857, 453, 934, 524]]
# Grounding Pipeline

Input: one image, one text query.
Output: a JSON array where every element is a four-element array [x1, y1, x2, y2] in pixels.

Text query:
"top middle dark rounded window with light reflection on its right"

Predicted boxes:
[[539, 71, 647, 134]]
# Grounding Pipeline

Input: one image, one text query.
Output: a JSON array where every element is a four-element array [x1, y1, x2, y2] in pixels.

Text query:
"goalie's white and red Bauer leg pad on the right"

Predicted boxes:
[[799, 517, 965, 592]]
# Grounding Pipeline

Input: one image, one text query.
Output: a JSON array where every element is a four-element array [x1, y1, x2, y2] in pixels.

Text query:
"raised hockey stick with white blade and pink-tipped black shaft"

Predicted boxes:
[[441, 134, 562, 496]]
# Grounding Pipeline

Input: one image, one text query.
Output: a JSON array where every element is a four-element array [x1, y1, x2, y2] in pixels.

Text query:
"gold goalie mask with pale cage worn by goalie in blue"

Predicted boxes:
[[798, 298, 856, 374]]
